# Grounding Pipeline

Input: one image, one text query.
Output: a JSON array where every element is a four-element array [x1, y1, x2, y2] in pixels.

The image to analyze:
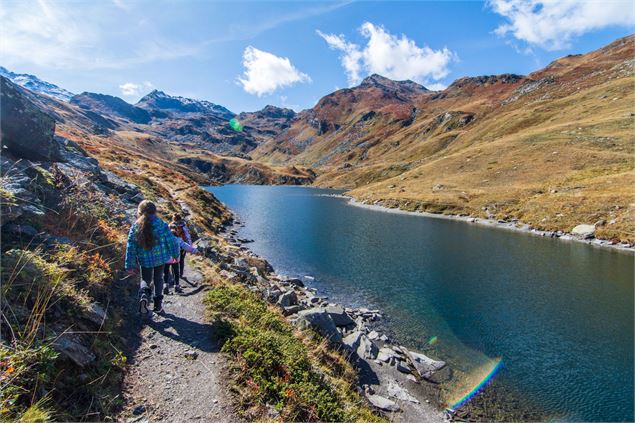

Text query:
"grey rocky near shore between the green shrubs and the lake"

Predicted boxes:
[[196, 220, 451, 422]]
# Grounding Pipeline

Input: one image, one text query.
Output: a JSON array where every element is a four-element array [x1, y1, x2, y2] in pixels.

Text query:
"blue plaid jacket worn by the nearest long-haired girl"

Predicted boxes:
[[126, 216, 179, 269]]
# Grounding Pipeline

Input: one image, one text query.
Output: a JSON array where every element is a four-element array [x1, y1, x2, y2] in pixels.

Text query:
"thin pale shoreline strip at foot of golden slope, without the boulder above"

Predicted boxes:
[[336, 194, 635, 254]]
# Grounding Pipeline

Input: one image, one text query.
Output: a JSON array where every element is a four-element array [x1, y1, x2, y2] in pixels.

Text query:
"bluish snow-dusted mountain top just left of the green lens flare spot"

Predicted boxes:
[[136, 90, 235, 120]]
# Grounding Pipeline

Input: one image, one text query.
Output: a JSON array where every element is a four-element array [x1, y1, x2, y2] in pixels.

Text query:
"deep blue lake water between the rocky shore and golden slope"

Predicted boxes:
[[210, 185, 634, 421]]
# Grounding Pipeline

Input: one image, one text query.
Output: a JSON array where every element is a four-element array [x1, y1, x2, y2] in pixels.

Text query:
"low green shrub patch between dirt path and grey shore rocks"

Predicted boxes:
[[205, 283, 383, 422]]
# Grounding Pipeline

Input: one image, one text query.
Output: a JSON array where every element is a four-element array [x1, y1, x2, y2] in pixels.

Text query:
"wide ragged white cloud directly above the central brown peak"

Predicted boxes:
[[317, 22, 456, 85]]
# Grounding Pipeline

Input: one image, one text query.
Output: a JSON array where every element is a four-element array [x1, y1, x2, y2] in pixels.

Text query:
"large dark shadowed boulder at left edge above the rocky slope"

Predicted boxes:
[[0, 77, 62, 161]]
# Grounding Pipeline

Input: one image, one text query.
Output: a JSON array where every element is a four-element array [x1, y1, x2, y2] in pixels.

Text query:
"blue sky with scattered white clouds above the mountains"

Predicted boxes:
[[0, 0, 635, 113]]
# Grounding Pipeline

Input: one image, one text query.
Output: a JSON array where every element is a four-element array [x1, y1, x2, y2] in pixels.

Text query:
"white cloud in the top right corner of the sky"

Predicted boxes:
[[487, 0, 635, 50]]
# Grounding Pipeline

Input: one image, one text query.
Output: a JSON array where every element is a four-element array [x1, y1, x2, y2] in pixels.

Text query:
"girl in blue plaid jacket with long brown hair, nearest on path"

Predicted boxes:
[[125, 200, 179, 313]]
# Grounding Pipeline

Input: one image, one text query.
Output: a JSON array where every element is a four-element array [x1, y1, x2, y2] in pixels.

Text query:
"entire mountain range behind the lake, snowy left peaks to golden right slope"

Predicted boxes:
[[2, 36, 635, 241]]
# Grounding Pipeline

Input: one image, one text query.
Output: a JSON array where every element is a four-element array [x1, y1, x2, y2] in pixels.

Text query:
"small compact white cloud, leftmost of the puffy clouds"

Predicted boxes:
[[238, 46, 311, 97]]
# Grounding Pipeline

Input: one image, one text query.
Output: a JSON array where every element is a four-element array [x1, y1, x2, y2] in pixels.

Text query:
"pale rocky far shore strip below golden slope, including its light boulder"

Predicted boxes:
[[342, 194, 635, 253]]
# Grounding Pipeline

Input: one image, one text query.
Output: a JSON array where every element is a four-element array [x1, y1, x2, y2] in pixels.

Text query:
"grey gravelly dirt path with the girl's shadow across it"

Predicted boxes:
[[119, 264, 236, 422]]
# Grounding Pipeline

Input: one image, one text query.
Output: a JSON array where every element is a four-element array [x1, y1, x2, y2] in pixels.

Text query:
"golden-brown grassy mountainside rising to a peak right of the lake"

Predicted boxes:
[[252, 36, 635, 242]]
